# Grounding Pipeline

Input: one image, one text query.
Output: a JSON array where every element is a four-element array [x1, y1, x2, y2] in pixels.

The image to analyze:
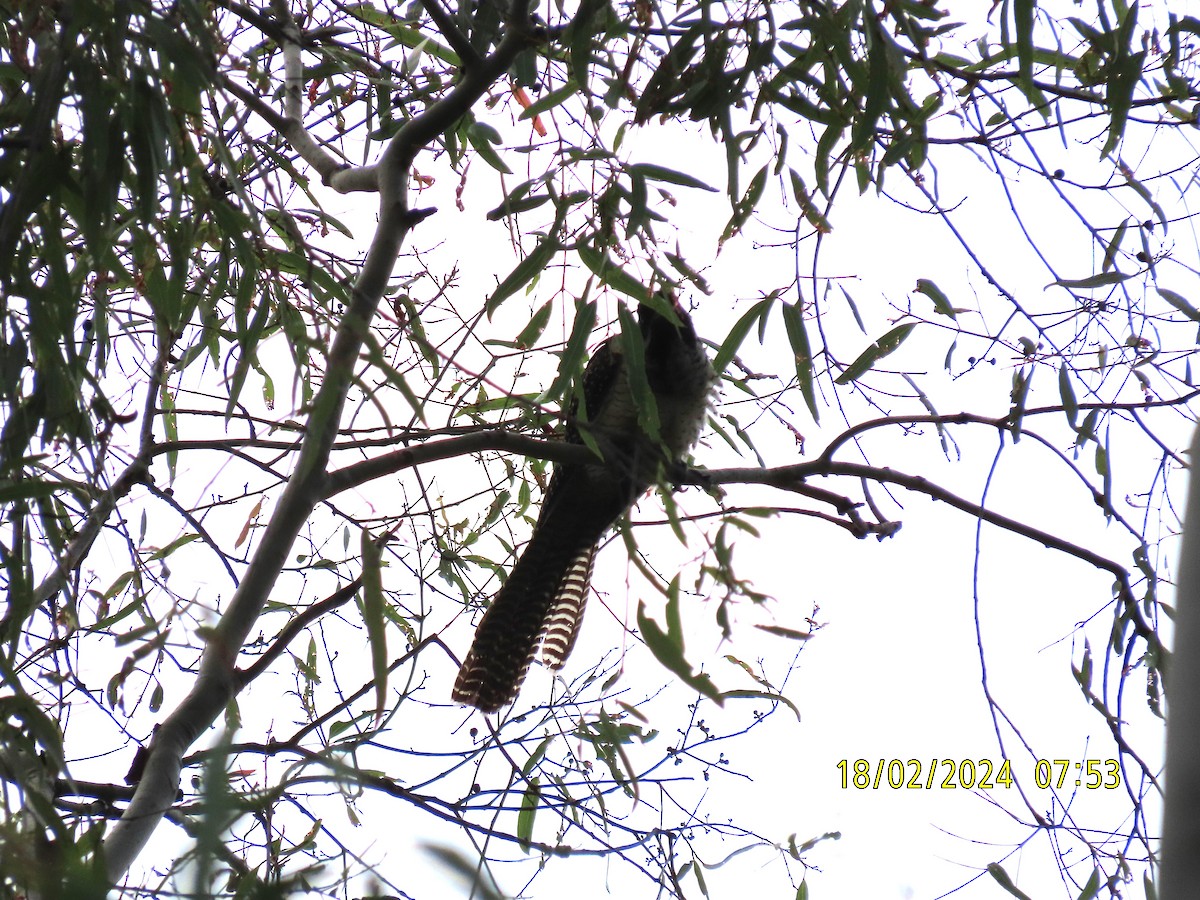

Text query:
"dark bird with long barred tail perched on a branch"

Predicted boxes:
[[451, 299, 715, 713]]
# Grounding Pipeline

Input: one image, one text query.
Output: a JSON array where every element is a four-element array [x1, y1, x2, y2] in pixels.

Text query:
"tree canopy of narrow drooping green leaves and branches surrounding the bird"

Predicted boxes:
[[0, 0, 1200, 898]]
